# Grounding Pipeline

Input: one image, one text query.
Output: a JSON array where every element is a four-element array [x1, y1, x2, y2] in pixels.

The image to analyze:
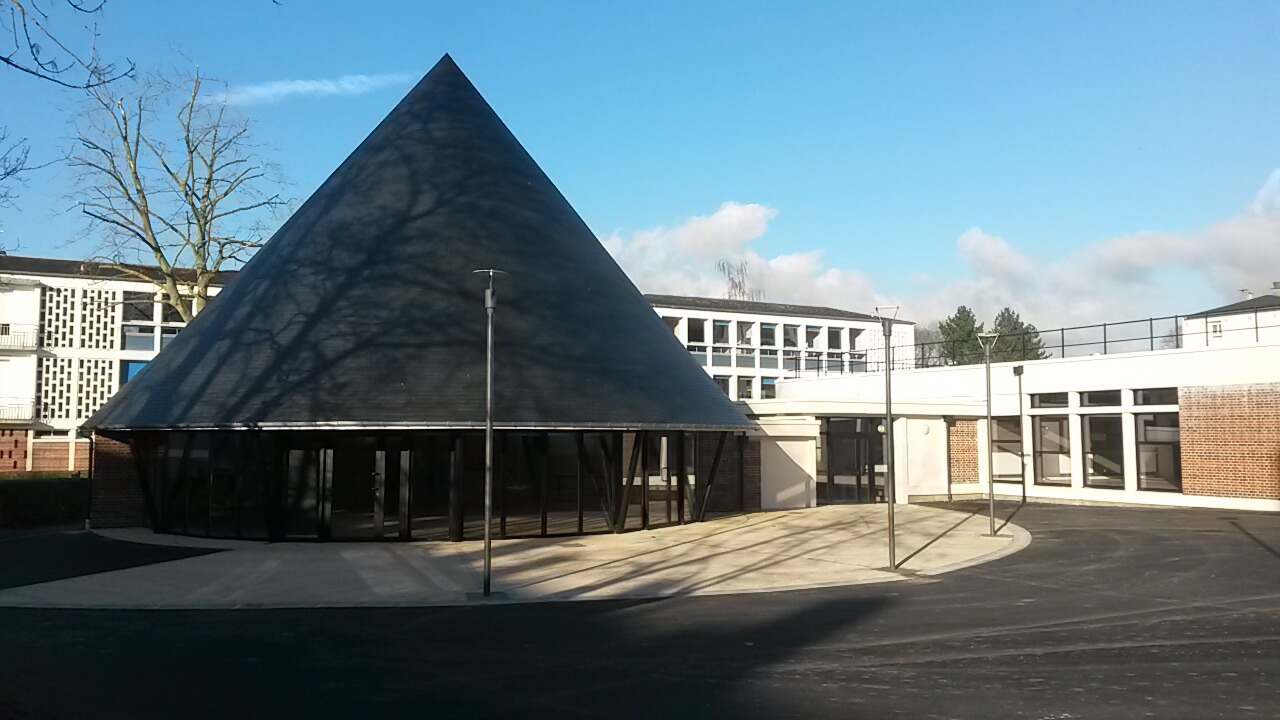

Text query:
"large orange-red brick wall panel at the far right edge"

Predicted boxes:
[[1178, 383, 1280, 500]]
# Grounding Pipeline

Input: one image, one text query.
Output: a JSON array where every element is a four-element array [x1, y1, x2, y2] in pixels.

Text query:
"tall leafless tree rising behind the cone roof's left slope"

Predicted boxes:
[[70, 73, 285, 320]]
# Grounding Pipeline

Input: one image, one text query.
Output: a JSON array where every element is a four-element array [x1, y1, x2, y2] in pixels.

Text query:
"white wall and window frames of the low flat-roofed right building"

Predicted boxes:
[[748, 343, 1280, 510]]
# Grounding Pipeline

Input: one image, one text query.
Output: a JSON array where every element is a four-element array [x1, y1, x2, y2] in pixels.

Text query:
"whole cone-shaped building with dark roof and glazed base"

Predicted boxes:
[[86, 56, 750, 537]]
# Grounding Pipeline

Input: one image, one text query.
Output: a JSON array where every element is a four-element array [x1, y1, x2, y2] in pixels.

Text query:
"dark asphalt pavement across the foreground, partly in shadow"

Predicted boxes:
[[0, 503, 1280, 719]]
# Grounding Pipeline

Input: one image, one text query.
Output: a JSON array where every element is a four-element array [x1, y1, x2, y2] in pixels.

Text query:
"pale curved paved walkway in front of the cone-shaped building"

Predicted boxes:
[[0, 505, 1030, 609]]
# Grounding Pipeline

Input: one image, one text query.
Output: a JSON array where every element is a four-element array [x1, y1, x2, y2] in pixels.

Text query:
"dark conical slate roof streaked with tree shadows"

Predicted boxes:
[[86, 55, 750, 430]]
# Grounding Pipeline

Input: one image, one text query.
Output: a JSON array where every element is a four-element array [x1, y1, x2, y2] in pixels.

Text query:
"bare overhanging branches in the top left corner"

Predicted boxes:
[[0, 0, 134, 88]]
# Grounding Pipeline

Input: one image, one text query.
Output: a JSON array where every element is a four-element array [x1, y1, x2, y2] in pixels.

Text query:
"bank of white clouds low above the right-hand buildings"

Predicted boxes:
[[602, 170, 1280, 329]]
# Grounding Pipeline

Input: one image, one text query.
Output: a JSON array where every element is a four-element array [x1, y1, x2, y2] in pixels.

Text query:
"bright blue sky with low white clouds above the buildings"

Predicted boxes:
[[0, 0, 1280, 327]]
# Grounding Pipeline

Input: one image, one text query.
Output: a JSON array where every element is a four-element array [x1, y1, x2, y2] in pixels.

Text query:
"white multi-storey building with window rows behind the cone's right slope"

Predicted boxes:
[[645, 295, 915, 401]]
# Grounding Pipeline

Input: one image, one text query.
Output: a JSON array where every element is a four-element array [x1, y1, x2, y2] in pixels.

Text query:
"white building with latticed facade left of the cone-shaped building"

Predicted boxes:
[[0, 254, 221, 473]]
